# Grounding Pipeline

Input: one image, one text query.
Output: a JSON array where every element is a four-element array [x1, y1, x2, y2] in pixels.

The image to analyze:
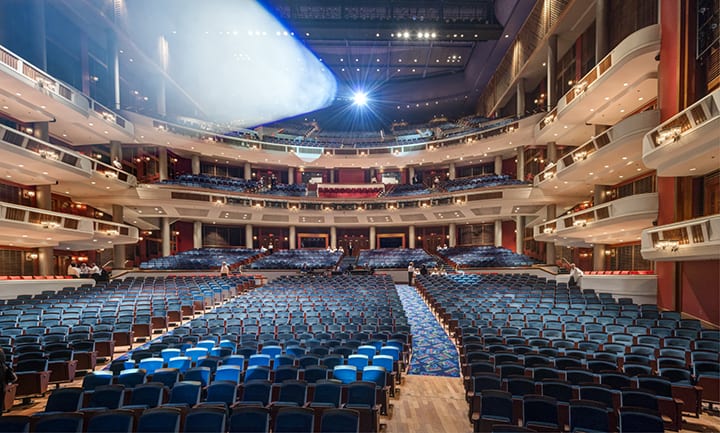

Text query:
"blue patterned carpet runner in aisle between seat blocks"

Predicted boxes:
[[395, 284, 460, 377]]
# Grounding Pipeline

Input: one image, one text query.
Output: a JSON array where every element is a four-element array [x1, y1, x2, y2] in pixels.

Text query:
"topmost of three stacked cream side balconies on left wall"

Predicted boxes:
[[0, 47, 134, 145]]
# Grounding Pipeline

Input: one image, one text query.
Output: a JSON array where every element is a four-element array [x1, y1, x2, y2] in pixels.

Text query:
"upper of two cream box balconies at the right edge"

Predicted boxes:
[[642, 89, 720, 176]]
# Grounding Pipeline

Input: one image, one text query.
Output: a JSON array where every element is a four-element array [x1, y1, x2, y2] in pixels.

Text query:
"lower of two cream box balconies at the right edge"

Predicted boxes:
[[640, 215, 720, 262]]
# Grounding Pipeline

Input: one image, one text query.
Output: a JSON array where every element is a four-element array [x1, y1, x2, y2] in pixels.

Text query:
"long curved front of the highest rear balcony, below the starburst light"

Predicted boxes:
[[127, 113, 542, 168]]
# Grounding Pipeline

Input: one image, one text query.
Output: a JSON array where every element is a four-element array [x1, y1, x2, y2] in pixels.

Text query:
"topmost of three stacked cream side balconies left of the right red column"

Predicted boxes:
[[535, 24, 660, 145]]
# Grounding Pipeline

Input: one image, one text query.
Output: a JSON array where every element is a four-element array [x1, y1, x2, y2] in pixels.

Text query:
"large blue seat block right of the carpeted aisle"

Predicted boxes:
[[417, 274, 720, 431]]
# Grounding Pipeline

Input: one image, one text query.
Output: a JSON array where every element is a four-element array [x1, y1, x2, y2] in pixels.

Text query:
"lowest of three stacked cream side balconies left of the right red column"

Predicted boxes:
[[533, 193, 658, 247]]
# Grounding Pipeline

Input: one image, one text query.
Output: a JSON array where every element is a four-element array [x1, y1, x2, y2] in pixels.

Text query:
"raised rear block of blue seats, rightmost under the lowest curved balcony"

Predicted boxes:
[[437, 245, 537, 268]]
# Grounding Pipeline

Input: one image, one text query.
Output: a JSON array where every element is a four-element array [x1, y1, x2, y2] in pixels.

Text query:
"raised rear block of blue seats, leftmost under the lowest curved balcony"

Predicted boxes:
[[140, 248, 262, 270]]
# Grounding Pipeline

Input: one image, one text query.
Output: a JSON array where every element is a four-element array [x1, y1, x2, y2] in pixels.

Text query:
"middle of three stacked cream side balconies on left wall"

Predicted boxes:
[[0, 121, 137, 198]]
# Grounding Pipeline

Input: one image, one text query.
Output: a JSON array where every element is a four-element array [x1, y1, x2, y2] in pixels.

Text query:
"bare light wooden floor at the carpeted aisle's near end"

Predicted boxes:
[[381, 375, 472, 433]]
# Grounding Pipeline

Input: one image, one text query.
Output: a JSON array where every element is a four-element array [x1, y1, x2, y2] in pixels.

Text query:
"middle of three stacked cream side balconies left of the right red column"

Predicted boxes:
[[534, 111, 659, 196]]
